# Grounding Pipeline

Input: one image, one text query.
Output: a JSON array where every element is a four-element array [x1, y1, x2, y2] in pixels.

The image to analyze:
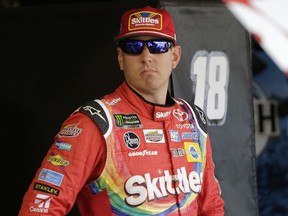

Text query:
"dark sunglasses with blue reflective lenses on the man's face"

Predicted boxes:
[[118, 40, 174, 55]]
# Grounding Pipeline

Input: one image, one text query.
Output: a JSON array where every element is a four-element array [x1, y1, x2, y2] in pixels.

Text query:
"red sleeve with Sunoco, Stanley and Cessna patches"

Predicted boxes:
[[18, 113, 106, 216]]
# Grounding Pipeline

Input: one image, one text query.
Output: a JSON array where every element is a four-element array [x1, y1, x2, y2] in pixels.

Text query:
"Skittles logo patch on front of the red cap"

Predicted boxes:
[[128, 11, 162, 31]]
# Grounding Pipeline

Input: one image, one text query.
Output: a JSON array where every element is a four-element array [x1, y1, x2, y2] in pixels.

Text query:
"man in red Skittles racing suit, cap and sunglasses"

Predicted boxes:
[[19, 6, 224, 216]]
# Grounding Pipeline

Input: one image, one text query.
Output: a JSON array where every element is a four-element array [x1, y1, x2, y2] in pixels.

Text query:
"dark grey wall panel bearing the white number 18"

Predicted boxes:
[[163, 1, 258, 216]]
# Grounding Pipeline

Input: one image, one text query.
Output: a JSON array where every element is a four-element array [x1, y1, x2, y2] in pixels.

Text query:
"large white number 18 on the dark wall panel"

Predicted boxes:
[[190, 50, 229, 125]]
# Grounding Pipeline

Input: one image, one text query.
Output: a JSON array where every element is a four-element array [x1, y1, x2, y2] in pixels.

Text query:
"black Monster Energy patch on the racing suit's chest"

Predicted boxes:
[[114, 114, 143, 128]]
